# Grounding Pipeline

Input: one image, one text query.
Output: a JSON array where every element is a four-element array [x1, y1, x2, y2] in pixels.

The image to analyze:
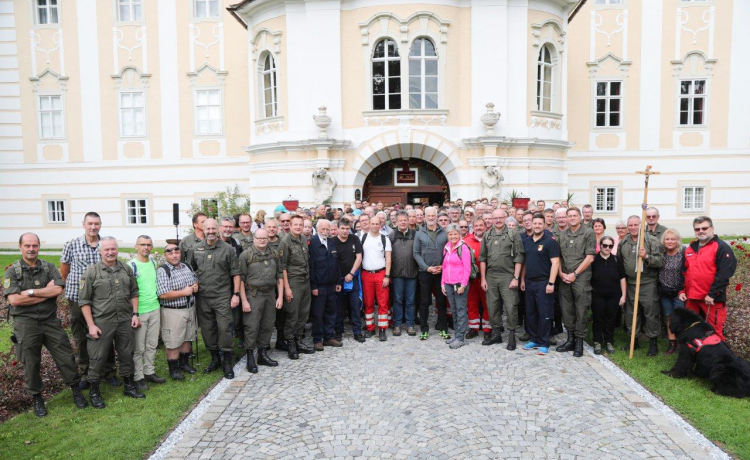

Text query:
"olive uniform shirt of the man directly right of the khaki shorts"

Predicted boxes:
[[187, 240, 240, 299]]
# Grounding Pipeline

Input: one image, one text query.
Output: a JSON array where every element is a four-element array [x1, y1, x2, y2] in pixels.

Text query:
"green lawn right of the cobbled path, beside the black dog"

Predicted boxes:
[[589, 328, 750, 459]]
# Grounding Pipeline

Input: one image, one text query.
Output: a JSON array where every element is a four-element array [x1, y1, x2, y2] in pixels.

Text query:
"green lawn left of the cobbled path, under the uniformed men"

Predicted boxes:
[[0, 343, 222, 460]]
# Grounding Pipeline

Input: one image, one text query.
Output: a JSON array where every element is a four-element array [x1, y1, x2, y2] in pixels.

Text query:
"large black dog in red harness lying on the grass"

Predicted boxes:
[[662, 308, 750, 398]]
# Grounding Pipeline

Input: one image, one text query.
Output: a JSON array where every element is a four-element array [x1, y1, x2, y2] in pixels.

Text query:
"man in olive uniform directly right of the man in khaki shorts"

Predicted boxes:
[[186, 219, 240, 379]]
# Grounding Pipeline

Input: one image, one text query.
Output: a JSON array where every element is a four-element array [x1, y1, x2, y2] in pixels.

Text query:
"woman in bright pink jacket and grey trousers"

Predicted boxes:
[[440, 224, 471, 349]]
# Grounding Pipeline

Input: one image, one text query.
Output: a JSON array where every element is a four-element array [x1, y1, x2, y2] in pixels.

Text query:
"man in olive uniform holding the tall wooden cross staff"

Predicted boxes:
[[617, 216, 664, 356]]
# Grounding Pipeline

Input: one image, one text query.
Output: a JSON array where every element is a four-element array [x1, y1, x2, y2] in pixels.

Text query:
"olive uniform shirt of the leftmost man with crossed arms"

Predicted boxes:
[[3, 259, 65, 321]]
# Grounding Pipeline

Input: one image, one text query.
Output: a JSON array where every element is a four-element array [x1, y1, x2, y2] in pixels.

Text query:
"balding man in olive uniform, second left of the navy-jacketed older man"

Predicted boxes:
[[240, 228, 284, 373]]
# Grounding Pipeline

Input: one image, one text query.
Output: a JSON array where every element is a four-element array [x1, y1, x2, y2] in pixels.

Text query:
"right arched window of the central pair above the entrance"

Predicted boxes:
[[409, 38, 438, 109]]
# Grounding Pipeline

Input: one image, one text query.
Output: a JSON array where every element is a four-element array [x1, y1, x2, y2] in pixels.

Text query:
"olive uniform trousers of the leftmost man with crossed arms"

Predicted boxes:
[[13, 318, 81, 395]]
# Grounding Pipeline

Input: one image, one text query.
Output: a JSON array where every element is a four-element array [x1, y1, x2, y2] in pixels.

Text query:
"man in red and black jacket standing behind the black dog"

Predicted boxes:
[[679, 216, 737, 340]]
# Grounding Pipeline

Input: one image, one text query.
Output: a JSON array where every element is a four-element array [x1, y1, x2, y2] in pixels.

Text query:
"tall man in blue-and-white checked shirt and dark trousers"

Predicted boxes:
[[60, 212, 122, 390]]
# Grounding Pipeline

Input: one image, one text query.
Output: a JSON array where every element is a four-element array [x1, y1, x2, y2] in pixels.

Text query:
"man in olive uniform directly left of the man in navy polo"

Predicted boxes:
[[479, 209, 525, 350]]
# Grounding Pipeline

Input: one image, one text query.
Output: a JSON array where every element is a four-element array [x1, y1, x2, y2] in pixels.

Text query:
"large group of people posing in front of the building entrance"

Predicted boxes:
[[4, 199, 736, 416]]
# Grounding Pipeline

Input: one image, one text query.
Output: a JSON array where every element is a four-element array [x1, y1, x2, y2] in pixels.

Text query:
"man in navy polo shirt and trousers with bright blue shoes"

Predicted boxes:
[[521, 213, 560, 355]]
